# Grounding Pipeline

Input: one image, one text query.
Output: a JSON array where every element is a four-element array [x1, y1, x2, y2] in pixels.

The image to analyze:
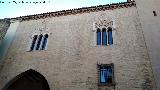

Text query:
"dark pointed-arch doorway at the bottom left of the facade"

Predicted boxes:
[[3, 69, 50, 90]]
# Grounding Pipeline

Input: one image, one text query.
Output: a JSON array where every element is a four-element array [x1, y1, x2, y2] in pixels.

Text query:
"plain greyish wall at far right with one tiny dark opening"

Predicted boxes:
[[135, 0, 160, 90]]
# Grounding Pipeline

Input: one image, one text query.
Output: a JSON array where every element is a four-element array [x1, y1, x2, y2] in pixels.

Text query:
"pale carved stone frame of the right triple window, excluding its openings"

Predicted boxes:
[[92, 20, 117, 47]]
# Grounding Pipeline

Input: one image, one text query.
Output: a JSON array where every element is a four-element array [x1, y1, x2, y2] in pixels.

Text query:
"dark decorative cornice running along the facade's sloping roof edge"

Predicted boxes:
[[11, 1, 136, 21]]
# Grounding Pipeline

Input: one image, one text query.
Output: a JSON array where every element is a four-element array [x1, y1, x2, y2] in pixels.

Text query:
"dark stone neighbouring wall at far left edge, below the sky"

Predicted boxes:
[[0, 19, 10, 43]]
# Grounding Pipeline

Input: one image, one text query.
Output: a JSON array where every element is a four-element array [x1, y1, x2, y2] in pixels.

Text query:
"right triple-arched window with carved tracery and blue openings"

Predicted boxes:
[[93, 20, 115, 46]]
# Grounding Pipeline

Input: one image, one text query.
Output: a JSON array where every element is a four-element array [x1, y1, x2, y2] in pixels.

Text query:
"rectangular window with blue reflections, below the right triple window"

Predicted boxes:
[[98, 64, 113, 85]]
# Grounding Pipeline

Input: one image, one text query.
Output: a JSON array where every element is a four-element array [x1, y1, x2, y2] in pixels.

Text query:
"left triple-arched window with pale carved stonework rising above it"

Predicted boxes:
[[27, 20, 51, 51]]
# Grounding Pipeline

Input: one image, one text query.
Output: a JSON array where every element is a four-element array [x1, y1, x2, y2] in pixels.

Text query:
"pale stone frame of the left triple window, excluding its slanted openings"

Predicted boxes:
[[27, 33, 49, 52]]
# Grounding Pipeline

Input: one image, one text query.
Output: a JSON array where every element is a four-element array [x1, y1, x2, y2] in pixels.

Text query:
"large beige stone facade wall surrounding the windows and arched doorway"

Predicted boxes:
[[0, 7, 154, 90]]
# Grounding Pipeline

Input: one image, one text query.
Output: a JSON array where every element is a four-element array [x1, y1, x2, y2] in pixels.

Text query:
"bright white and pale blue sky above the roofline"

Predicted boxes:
[[0, 0, 127, 19]]
